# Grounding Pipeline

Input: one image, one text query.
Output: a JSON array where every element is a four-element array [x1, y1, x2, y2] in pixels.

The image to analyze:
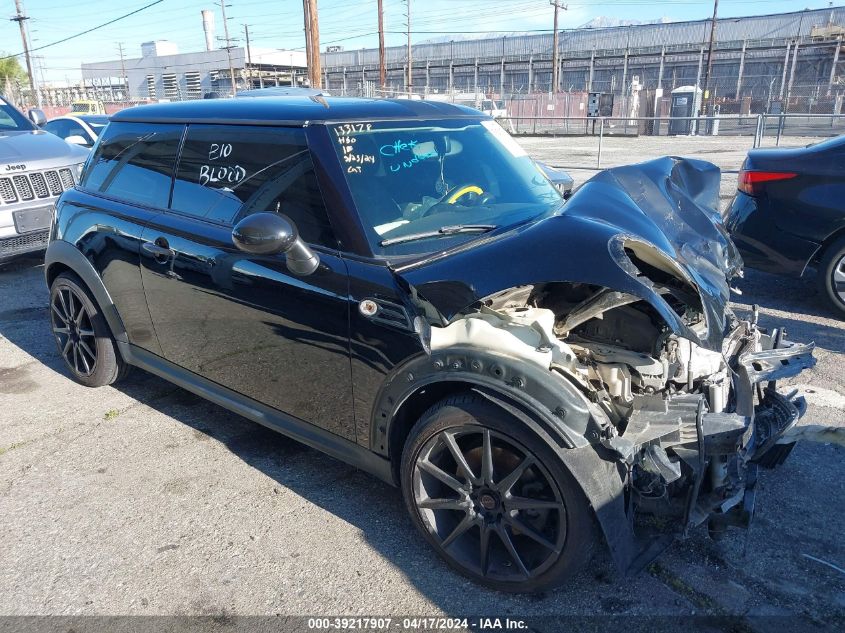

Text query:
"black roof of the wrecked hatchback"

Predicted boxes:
[[111, 96, 486, 126]]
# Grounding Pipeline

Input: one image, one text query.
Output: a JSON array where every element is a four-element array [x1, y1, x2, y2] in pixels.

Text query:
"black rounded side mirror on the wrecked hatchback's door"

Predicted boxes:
[[232, 213, 320, 276]]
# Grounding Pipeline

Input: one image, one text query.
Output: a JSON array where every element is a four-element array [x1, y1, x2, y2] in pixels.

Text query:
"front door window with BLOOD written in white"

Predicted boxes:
[[171, 125, 337, 247]]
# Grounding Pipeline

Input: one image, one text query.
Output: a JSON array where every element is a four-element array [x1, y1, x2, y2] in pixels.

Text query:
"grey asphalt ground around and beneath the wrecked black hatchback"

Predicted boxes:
[[0, 136, 845, 631]]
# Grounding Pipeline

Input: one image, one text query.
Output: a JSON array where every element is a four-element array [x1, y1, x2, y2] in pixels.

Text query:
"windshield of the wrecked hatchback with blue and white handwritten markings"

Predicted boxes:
[[330, 120, 563, 256]]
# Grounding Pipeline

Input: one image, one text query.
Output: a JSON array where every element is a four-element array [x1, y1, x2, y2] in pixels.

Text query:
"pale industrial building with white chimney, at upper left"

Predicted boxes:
[[82, 11, 307, 101]]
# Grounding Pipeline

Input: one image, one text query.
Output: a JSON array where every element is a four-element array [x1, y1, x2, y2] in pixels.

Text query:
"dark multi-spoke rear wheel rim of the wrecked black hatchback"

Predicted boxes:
[[50, 286, 97, 376]]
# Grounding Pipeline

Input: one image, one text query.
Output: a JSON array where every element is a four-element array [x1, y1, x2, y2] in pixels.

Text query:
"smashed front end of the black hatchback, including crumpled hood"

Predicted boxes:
[[388, 158, 814, 572]]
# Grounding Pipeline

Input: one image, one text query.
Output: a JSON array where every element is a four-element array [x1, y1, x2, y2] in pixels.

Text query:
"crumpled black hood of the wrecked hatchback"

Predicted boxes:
[[396, 157, 742, 351]]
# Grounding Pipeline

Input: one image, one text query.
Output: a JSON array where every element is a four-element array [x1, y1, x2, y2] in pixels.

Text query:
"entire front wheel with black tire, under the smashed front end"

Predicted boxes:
[[400, 394, 597, 592]]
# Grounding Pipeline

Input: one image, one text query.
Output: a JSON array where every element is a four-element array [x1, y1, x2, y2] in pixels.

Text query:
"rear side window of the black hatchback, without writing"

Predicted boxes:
[[82, 123, 184, 209]]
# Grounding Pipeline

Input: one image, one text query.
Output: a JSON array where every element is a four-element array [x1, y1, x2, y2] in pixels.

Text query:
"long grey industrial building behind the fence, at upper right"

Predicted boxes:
[[322, 7, 845, 112]]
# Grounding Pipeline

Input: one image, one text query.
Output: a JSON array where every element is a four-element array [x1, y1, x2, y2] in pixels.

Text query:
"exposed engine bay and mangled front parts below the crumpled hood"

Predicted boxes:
[[431, 283, 814, 548]]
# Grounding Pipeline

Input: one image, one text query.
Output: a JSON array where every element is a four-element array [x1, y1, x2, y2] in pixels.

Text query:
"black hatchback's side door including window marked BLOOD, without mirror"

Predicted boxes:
[[141, 125, 355, 440]]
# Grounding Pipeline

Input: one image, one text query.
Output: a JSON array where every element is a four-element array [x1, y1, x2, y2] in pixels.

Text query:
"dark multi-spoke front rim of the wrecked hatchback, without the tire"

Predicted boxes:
[[413, 426, 566, 582]]
